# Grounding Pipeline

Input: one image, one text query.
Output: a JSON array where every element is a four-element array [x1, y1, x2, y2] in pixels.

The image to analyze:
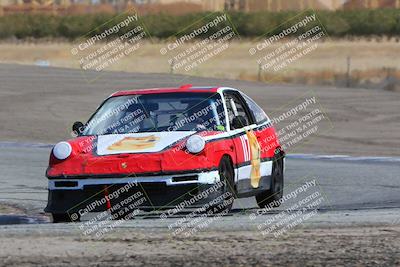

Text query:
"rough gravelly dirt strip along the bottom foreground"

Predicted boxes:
[[0, 226, 400, 266]]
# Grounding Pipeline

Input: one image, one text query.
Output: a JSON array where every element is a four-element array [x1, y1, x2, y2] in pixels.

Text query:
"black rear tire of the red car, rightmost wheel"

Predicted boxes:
[[256, 157, 284, 208]]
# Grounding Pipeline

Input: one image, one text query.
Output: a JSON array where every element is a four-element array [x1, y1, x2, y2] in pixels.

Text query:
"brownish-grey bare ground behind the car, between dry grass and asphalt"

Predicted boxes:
[[0, 65, 400, 156]]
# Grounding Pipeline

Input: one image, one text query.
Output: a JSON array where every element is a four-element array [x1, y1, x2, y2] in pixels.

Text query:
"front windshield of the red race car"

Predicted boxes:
[[83, 93, 225, 135]]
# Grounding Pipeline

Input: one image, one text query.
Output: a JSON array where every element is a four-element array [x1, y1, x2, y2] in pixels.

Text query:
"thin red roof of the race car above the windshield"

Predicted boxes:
[[111, 84, 234, 96]]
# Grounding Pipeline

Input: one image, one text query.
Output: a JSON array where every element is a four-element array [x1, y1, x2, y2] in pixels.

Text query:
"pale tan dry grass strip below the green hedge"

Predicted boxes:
[[0, 40, 400, 84]]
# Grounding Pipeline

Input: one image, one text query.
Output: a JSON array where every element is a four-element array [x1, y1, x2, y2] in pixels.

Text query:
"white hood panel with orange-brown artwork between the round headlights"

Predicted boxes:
[[96, 131, 195, 156]]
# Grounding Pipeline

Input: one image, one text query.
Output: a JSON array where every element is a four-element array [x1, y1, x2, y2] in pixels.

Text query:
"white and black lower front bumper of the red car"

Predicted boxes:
[[45, 170, 222, 214]]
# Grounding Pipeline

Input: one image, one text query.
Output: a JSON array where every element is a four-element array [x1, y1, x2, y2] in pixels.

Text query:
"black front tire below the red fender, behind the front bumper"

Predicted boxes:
[[208, 156, 235, 215]]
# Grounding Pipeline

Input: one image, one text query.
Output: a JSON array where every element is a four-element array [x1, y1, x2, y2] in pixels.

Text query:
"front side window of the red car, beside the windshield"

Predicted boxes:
[[224, 93, 250, 130]]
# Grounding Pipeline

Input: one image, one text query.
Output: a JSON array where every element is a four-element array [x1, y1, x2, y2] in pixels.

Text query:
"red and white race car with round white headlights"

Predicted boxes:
[[45, 85, 285, 222]]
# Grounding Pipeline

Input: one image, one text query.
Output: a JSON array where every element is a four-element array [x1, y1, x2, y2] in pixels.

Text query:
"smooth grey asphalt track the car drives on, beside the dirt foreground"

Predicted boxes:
[[0, 142, 400, 225]]
